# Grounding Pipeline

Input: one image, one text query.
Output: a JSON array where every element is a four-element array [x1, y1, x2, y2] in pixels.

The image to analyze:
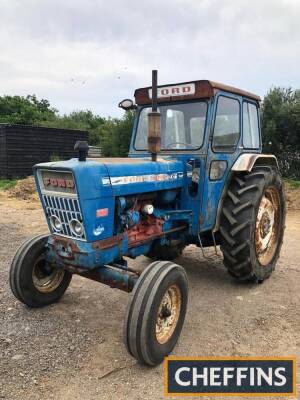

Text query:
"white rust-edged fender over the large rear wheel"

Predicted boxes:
[[213, 153, 279, 232]]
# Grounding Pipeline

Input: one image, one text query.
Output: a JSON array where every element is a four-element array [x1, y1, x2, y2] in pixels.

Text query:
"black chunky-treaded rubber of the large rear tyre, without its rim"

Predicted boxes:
[[219, 166, 286, 282]]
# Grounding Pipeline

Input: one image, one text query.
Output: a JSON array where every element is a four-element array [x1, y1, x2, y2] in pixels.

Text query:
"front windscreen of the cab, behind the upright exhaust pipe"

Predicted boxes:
[[134, 101, 207, 151]]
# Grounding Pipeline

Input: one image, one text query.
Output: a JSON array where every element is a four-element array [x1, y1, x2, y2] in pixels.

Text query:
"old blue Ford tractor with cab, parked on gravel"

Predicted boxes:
[[10, 71, 285, 365]]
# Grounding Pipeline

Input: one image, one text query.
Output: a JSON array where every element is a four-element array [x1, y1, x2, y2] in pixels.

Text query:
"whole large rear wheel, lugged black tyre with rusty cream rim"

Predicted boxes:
[[220, 167, 285, 282]]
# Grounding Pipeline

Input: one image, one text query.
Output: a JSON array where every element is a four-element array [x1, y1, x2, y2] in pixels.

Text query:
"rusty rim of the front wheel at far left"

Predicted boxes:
[[32, 255, 65, 293]]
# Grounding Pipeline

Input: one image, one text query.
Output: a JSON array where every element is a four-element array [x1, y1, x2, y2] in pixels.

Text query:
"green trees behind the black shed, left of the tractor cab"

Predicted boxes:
[[0, 95, 134, 156]]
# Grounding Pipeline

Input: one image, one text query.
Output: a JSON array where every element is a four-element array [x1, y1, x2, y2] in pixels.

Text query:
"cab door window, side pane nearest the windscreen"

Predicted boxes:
[[212, 96, 240, 152]]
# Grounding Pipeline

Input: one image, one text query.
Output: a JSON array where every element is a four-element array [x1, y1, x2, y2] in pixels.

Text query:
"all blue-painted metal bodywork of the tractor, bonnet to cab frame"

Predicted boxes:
[[35, 92, 261, 290]]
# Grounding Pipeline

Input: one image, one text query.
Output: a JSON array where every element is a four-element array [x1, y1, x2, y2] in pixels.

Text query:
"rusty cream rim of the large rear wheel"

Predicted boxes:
[[255, 187, 280, 266]]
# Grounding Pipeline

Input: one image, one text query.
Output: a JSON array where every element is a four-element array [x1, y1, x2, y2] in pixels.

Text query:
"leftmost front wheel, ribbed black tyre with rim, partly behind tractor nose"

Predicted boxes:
[[10, 235, 72, 307]]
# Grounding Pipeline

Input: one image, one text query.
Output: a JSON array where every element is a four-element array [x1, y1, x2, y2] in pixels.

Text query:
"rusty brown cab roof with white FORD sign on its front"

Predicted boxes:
[[134, 80, 261, 105]]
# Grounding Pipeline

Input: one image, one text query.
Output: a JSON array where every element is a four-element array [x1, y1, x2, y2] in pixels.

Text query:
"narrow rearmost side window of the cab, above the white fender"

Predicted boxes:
[[243, 101, 259, 149]]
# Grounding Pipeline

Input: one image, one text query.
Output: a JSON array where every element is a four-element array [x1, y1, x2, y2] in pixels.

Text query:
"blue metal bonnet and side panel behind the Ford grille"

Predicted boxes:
[[35, 159, 186, 242]]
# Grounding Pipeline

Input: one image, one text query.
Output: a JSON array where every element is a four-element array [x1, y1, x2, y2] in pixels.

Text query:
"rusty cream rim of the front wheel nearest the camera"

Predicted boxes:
[[156, 285, 182, 344]]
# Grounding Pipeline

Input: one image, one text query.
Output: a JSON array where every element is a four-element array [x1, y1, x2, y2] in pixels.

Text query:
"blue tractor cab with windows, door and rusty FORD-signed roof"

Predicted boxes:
[[120, 80, 261, 231]]
